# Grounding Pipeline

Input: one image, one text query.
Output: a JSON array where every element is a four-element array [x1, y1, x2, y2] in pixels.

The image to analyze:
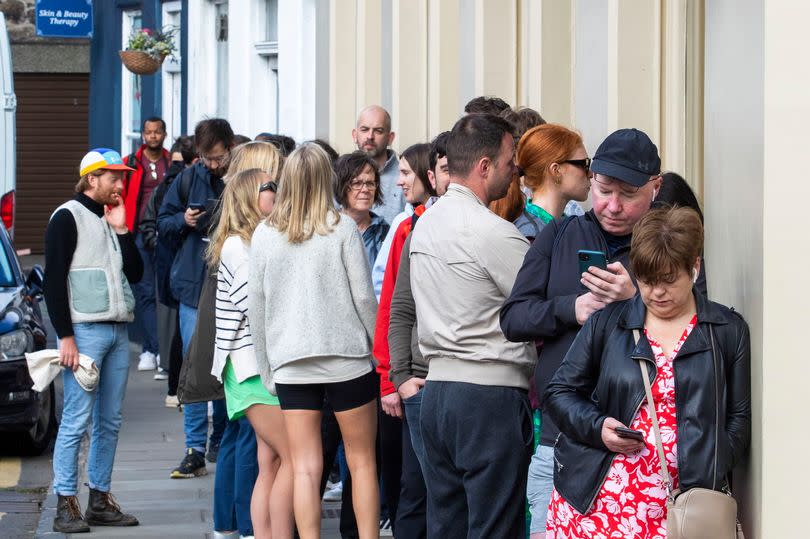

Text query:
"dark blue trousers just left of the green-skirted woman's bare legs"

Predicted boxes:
[[214, 417, 259, 535]]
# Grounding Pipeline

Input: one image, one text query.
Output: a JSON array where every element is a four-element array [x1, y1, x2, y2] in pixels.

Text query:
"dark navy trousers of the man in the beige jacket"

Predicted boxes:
[[421, 381, 533, 539]]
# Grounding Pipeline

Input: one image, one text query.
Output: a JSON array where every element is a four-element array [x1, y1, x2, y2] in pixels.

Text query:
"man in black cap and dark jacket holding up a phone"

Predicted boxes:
[[501, 129, 706, 539]]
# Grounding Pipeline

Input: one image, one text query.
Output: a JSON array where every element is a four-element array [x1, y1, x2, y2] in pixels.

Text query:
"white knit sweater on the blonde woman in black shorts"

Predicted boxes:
[[248, 215, 377, 388]]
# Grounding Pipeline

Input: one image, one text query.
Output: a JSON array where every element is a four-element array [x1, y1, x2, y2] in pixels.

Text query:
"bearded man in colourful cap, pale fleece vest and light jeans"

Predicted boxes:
[[43, 148, 143, 533]]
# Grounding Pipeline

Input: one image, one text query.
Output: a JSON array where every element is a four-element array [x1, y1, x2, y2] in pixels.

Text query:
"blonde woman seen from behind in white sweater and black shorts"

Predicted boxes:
[[248, 143, 379, 539]]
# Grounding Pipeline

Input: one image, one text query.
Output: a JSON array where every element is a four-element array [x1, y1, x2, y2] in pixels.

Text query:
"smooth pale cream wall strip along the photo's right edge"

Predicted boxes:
[[760, 0, 810, 538]]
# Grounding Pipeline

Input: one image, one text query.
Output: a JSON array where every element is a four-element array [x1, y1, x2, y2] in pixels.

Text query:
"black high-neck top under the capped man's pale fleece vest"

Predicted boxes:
[[42, 193, 143, 339]]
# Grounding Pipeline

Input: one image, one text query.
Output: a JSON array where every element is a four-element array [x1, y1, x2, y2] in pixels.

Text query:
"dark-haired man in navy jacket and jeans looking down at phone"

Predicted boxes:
[[157, 118, 234, 479]]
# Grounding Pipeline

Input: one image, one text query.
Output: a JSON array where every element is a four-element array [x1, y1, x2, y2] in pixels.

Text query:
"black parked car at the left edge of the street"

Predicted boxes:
[[0, 220, 50, 455]]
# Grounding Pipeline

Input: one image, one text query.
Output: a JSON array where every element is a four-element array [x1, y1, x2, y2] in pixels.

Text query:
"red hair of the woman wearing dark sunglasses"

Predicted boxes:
[[517, 124, 583, 189]]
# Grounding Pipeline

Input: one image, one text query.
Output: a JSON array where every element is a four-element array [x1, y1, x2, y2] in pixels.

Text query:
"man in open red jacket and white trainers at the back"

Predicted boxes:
[[124, 116, 172, 379]]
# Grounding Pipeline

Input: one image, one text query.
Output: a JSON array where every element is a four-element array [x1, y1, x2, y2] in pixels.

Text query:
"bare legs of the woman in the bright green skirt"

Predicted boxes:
[[247, 404, 293, 539]]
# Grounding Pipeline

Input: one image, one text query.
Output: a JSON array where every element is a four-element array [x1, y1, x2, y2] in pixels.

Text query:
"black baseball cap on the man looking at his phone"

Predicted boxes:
[[591, 129, 661, 187]]
